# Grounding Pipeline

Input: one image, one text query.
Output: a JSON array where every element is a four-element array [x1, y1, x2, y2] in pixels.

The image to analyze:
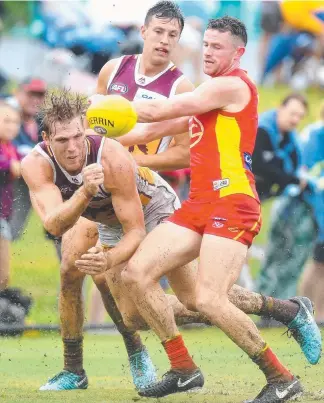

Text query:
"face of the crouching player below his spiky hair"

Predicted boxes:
[[45, 117, 86, 174]]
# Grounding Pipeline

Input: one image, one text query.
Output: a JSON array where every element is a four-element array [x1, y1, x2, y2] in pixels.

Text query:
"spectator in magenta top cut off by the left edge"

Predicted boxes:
[[0, 101, 20, 291]]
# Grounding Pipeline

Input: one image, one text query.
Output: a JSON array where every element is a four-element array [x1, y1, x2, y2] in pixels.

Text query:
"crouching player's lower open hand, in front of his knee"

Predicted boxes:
[[75, 246, 112, 276]]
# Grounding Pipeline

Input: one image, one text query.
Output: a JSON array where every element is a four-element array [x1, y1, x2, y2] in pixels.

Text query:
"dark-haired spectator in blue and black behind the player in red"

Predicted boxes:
[[253, 94, 314, 316]]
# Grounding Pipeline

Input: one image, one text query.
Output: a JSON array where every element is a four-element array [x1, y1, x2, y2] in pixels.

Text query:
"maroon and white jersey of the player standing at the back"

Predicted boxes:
[[107, 55, 184, 155]]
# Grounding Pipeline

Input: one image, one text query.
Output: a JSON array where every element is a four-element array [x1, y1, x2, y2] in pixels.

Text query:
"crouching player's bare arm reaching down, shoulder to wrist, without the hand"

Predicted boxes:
[[102, 140, 146, 266]]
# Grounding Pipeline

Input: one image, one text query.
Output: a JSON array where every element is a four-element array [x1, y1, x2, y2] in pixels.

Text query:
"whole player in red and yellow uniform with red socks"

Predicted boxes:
[[122, 17, 308, 403]]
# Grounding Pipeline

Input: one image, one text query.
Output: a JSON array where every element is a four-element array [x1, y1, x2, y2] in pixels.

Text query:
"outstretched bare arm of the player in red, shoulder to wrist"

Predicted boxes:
[[133, 77, 251, 123]]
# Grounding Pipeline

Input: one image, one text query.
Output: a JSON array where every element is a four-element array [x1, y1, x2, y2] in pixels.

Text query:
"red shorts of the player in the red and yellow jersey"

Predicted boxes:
[[168, 194, 261, 246]]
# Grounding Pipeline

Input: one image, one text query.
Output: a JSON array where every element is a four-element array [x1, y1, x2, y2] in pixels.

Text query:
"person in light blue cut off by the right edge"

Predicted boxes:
[[301, 104, 324, 323]]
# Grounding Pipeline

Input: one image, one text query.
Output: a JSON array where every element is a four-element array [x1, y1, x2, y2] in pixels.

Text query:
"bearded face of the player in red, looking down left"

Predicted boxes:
[[203, 29, 245, 77]]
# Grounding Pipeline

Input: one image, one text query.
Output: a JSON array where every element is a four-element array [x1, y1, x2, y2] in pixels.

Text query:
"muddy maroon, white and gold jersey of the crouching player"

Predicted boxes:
[[34, 135, 157, 225]]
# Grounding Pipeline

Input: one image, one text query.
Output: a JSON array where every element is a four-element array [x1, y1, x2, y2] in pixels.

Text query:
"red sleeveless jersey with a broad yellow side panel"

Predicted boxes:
[[189, 69, 258, 201]]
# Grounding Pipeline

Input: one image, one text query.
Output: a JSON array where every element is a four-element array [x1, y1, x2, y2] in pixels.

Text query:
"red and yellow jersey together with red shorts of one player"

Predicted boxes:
[[169, 69, 261, 246]]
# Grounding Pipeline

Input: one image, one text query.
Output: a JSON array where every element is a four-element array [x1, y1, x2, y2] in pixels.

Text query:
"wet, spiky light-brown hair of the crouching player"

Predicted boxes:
[[38, 89, 89, 135]]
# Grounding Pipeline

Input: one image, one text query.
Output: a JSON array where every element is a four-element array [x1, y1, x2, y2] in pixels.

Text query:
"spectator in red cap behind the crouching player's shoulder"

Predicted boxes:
[[8, 78, 46, 240]]
